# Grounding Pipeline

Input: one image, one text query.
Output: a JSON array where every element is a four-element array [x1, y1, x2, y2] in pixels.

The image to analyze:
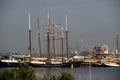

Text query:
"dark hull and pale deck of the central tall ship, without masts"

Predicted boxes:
[[30, 58, 82, 67]]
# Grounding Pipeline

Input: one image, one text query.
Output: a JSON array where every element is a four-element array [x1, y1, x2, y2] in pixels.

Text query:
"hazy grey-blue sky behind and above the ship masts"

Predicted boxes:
[[0, 0, 120, 53]]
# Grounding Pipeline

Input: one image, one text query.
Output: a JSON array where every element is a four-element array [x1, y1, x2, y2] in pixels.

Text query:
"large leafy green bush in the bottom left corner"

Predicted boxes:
[[0, 65, 36, 80]]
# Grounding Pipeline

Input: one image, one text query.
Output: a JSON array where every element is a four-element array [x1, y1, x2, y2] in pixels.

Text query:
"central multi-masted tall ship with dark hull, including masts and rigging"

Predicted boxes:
[[28, 13, 82, 67]]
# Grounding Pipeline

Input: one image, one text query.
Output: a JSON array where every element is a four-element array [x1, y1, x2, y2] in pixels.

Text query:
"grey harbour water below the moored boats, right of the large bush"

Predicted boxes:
[[34, 67, 120, 80]]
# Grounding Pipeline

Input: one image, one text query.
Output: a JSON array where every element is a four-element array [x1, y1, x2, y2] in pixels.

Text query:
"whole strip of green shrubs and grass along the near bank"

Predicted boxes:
[[0, 64, 74, 80]]
